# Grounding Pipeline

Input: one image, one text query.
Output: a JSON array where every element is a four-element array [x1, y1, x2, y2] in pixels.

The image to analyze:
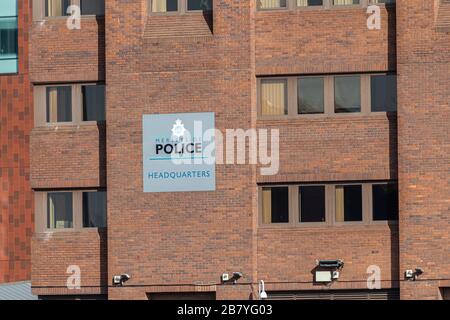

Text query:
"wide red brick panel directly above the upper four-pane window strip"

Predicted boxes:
[[256, 7, 395, 75]]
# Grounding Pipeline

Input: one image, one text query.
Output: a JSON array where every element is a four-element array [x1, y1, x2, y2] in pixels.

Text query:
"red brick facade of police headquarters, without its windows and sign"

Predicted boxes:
[[31, 0, 450, 299]]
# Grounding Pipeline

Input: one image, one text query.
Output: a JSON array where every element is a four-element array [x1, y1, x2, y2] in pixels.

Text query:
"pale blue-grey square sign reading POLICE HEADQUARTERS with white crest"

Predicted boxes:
[[143, 112, 216, 192]]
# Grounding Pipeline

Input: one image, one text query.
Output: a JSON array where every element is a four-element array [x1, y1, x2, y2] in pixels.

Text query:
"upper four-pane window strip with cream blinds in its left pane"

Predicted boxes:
[[257, 74, 397, 119]]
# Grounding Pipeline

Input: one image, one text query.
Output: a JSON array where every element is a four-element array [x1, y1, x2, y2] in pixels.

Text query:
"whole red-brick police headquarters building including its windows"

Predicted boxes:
[[30, 0, 450, 299]]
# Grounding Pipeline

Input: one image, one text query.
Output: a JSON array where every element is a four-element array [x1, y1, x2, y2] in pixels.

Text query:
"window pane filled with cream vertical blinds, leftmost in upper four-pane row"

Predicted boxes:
[[261, 79, 288, 116]]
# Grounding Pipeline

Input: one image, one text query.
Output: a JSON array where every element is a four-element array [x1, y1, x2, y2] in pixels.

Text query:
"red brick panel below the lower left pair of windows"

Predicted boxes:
[[32, 229, 108, 295]]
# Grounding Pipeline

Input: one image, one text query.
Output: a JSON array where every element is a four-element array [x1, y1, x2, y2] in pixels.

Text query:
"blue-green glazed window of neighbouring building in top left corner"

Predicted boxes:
[[0, 0, 18, 74]]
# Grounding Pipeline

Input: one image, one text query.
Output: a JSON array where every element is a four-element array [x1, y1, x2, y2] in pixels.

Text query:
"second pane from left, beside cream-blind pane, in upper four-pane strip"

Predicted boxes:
[[297, 77, 324, 114]]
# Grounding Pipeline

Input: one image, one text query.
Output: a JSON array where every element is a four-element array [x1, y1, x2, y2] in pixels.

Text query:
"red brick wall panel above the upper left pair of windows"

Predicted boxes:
[[30, 17, 105, 83]]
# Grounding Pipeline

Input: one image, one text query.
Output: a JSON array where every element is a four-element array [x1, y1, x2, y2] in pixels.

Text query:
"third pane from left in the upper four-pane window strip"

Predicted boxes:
[[334, 76, 361, 113]]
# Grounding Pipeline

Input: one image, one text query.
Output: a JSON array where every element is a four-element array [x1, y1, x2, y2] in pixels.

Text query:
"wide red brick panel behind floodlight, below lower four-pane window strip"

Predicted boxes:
[[258, 225, 398, 291]]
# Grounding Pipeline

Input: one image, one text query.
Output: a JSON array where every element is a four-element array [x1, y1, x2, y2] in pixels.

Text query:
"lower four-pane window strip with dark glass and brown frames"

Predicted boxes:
[[258, 181, 398, 227]]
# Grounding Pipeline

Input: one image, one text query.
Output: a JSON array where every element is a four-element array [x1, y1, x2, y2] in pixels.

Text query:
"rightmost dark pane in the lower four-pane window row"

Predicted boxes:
[[372, 183, 398, 221]]
